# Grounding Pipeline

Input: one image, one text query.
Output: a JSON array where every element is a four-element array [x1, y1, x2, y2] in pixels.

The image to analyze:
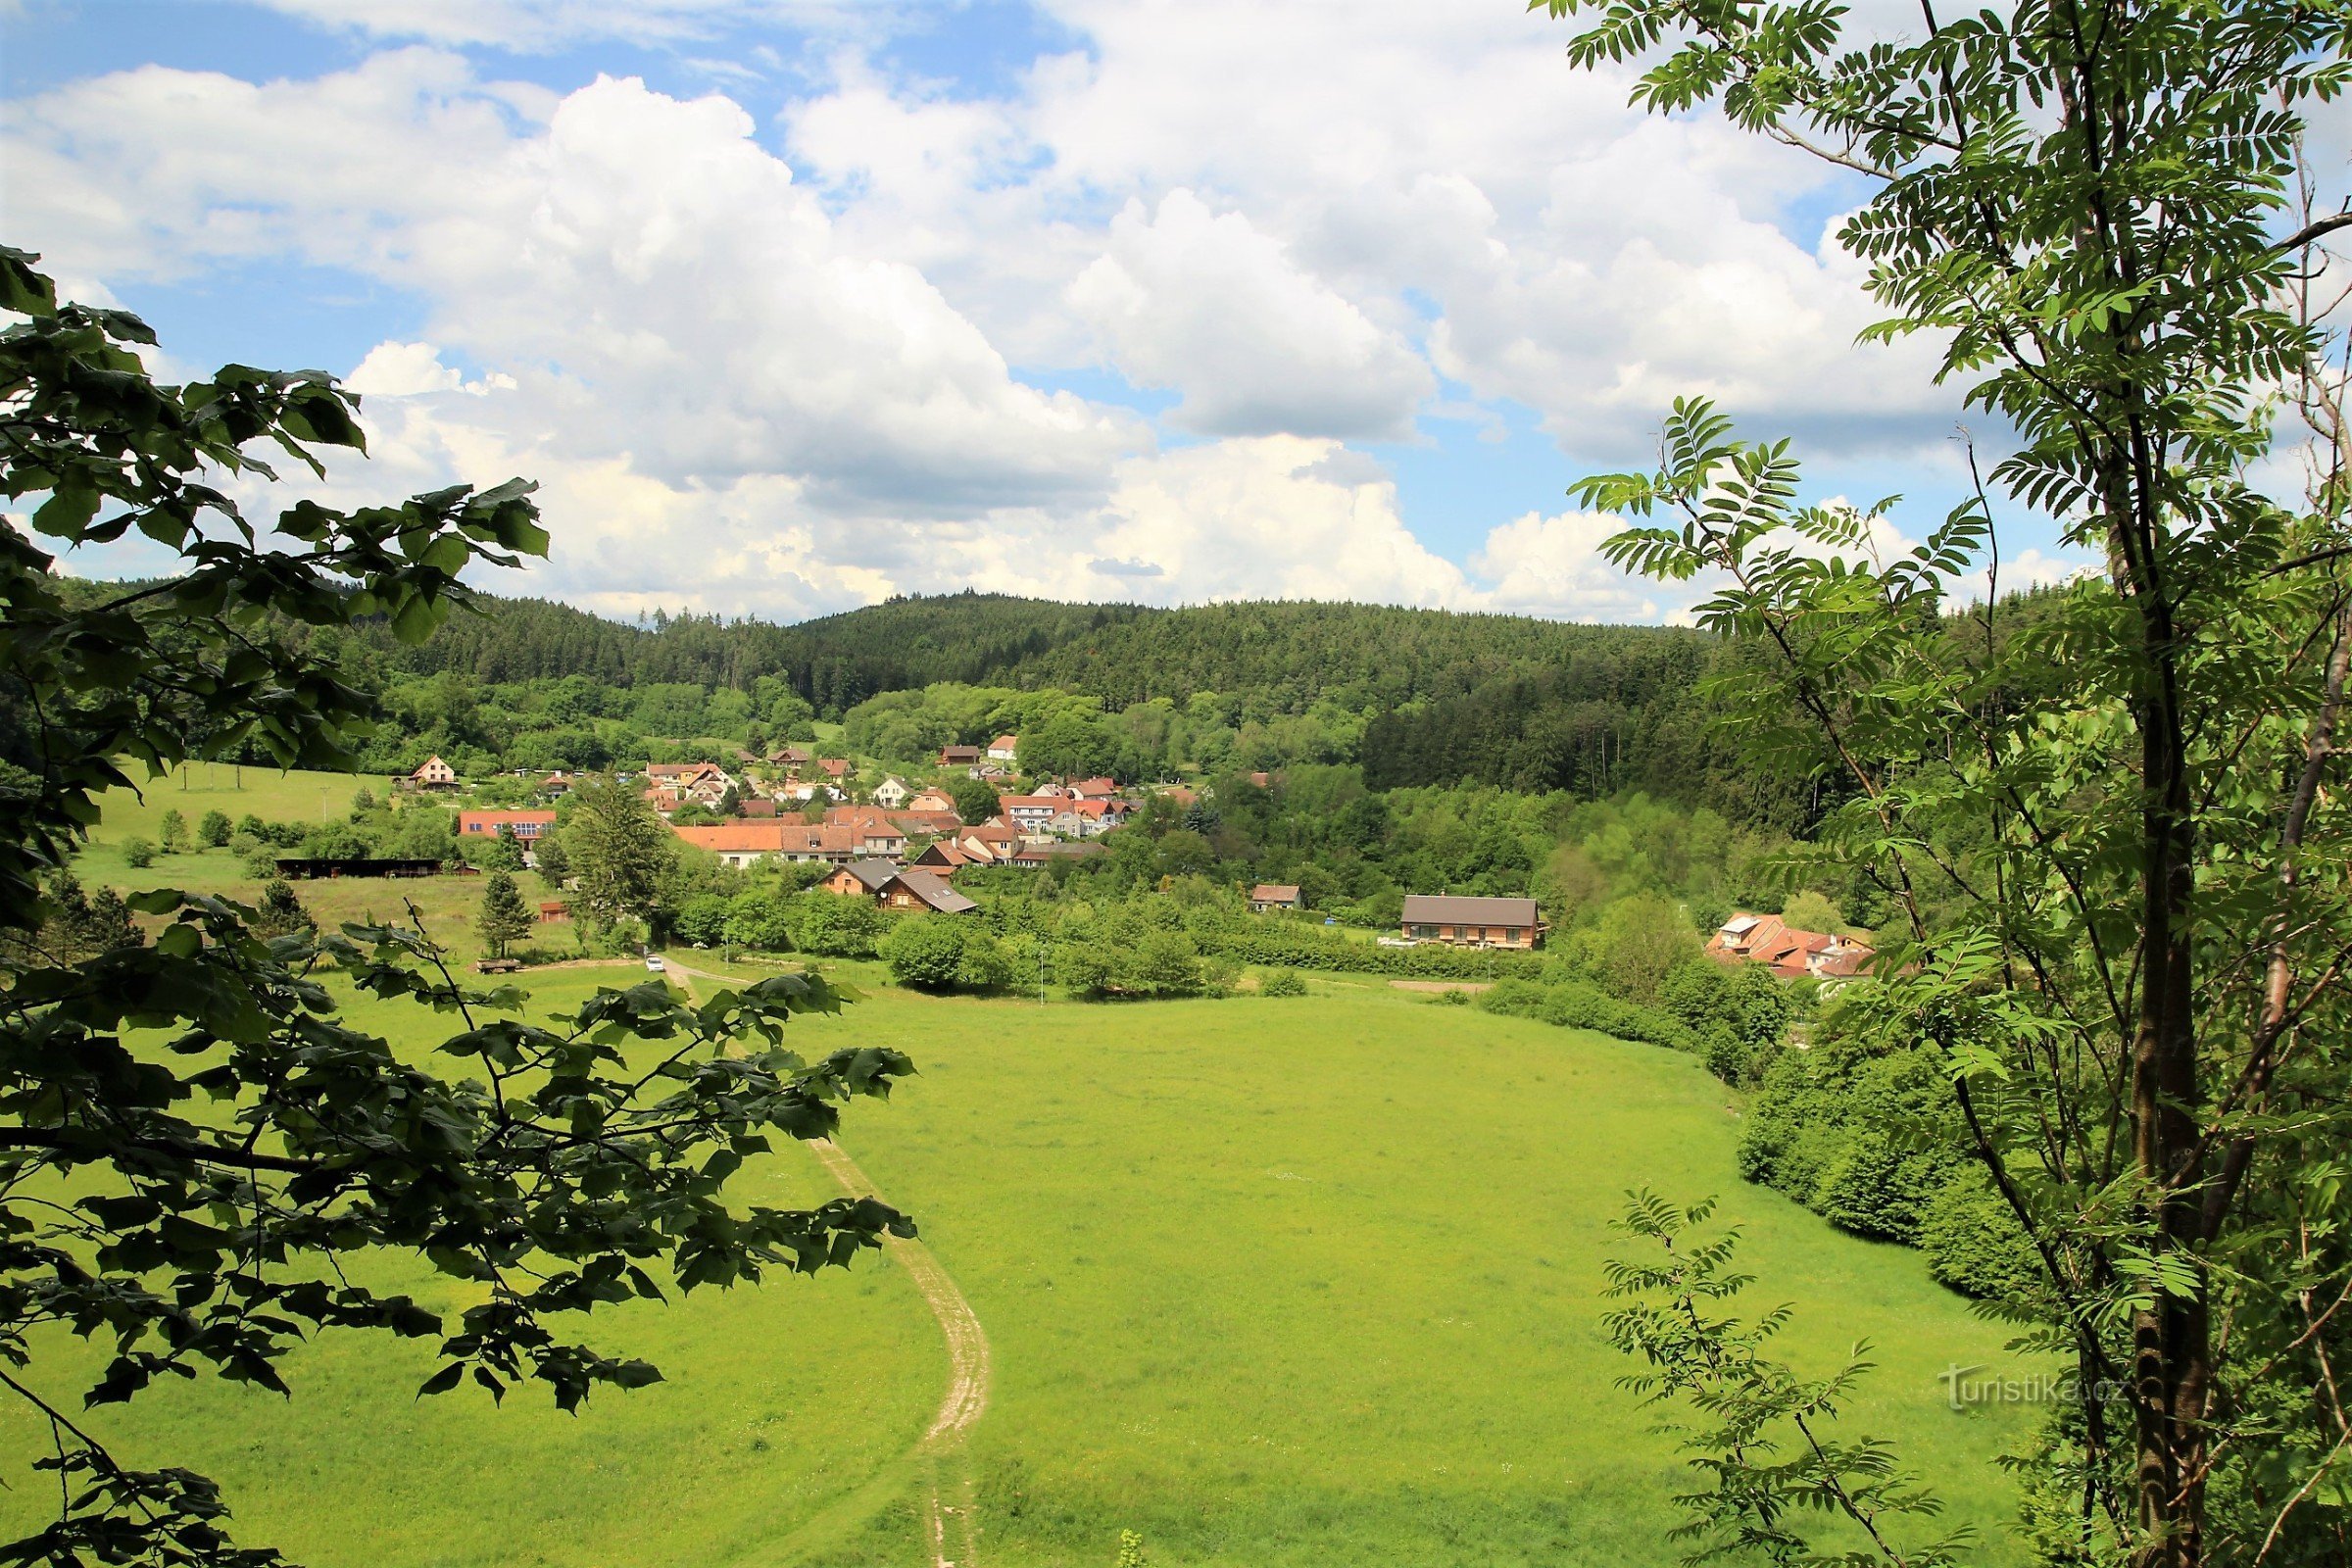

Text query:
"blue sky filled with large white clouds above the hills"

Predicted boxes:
[[0, 0, 2097, 620]]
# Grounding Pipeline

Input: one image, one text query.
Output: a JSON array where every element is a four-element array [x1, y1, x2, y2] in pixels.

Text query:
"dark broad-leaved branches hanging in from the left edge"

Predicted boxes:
[[0, 252, 912, 1566]]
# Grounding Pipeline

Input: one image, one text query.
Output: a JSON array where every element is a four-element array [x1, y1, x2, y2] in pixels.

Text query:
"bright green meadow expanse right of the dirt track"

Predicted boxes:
[[790, 985, 2021, 1568]]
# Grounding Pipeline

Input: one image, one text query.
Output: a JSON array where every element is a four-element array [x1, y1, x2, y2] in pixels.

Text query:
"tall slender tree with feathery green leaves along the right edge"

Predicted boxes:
[[1541, 0, 2352, 1568]]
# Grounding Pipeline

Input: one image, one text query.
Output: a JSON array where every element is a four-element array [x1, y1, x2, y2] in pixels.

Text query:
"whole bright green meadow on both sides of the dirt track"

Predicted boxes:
[[0, 930, 2025, 1568]]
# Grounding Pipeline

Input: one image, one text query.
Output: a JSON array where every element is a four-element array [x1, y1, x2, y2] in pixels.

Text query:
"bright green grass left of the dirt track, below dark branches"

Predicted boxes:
[[0, 966, 946, 1568]]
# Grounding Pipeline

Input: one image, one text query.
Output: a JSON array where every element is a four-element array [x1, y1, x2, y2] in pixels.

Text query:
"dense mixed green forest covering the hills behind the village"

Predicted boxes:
[[298, 592, 1768, 830]]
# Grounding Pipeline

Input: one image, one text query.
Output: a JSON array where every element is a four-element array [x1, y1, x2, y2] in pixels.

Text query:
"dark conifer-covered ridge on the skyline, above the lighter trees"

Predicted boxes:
[[378, 592, 1707, 717]]
